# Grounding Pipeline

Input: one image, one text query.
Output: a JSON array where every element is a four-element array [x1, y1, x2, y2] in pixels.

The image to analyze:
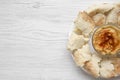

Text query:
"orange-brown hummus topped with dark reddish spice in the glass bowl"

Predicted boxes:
[[92, 25, 120, 55]]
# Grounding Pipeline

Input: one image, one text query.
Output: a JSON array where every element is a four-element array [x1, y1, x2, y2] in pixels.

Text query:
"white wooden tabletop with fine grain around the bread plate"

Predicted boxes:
[[0, 0, 120, 80]]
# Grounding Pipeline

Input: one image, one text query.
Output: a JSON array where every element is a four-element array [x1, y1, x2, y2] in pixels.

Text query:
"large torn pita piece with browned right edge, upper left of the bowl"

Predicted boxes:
[[75, 12, 95, 37]]
